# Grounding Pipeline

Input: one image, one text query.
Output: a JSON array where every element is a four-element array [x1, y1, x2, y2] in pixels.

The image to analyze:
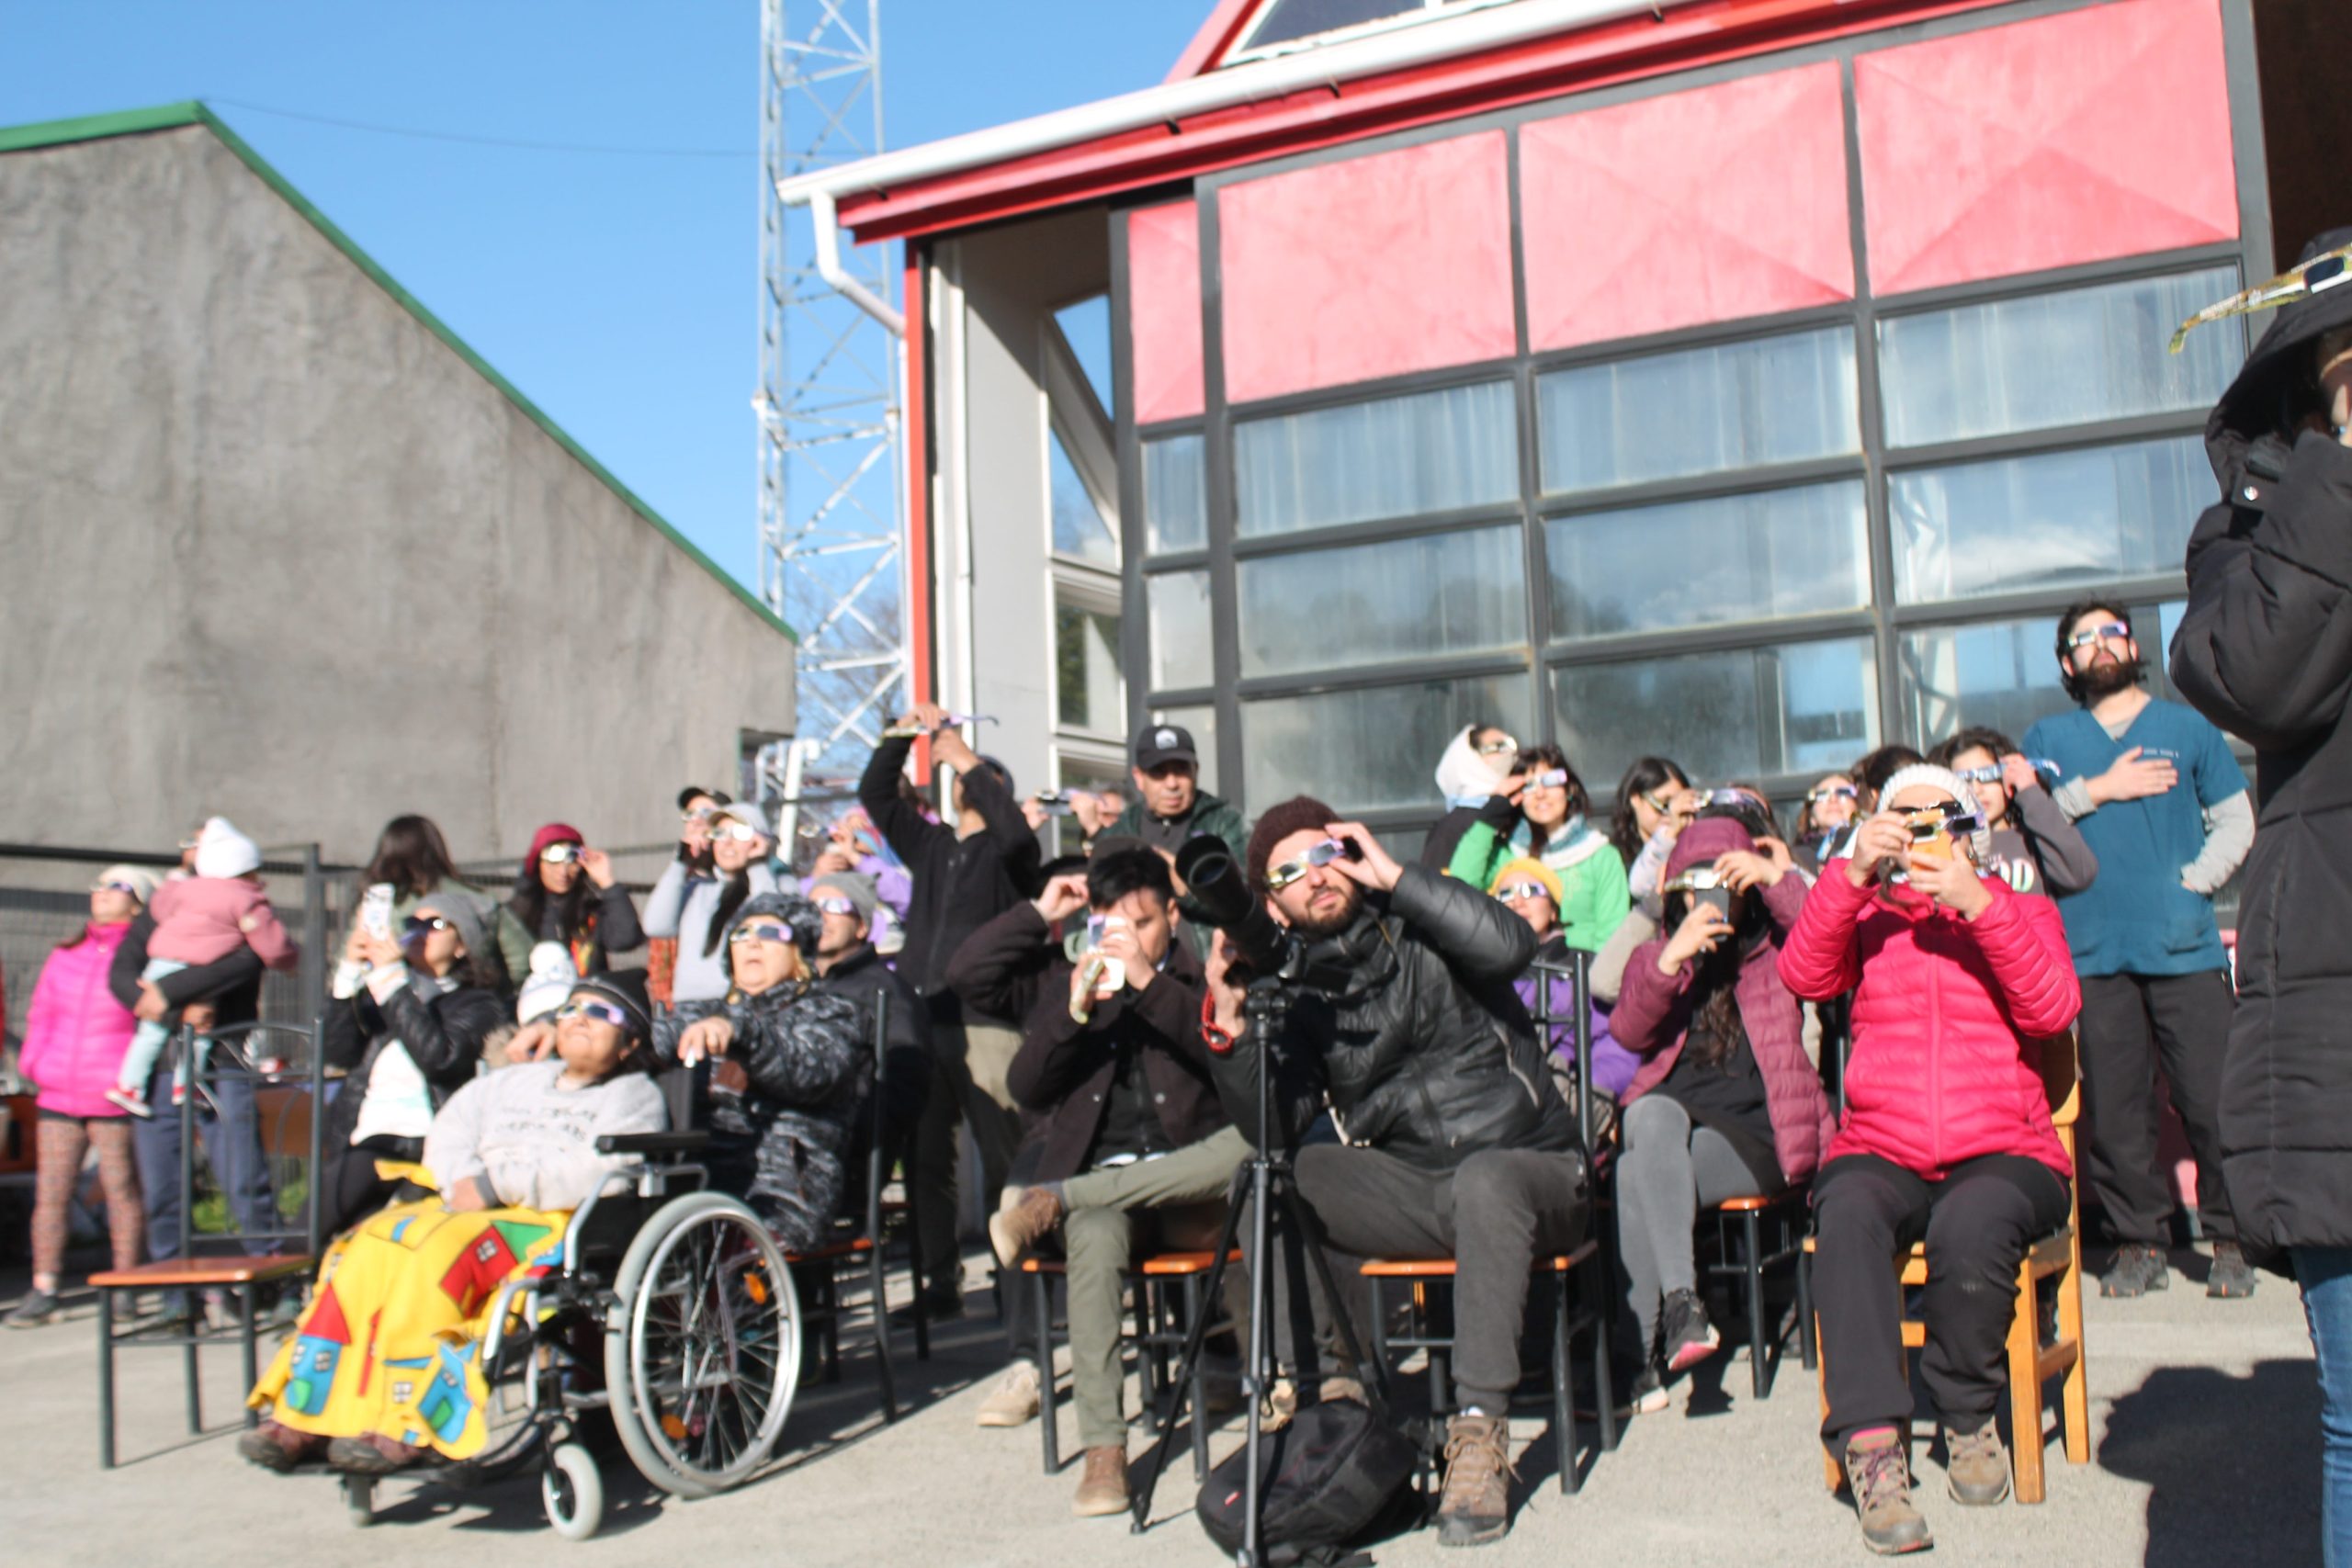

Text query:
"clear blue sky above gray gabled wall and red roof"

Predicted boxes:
[[0, 0, 1209, 592]]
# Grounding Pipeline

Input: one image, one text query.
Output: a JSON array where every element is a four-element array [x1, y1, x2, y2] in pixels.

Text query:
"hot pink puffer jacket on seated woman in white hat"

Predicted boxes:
[[1778, 861, 2082, 1180]]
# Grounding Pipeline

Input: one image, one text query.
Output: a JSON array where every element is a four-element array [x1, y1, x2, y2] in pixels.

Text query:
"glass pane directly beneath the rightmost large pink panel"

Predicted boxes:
[[1879, 265, 2246, 446]]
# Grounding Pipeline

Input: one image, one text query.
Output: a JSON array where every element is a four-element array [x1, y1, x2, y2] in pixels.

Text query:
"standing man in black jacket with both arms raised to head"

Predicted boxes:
[[858, 703, 1040, 1316]]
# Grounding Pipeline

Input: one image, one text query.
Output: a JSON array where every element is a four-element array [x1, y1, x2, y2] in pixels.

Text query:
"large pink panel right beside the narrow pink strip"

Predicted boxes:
[[1216, 131, 1517, 402]]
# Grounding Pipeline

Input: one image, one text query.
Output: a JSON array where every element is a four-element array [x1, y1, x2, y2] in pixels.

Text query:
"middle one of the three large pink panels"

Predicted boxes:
[[1520, 63, 1853, 350]]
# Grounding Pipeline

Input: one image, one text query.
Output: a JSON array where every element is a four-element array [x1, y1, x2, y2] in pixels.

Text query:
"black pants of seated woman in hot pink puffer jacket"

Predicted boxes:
[[1814, 1155, 2067, 1450]]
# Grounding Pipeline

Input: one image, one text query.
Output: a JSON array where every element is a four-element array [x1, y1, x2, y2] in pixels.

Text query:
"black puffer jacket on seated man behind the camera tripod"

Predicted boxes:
[[1211, 865, 1576, 1170]]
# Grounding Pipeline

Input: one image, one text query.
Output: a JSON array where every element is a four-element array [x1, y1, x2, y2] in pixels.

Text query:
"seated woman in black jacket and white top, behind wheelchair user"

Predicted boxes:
[[318, 896, 513, 1235]]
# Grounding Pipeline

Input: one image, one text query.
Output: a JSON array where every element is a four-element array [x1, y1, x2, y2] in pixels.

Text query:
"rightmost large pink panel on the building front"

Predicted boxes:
[[1853, 0, 2237, 294]]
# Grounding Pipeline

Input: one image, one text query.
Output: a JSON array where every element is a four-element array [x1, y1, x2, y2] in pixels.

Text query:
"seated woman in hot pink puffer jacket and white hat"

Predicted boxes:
[[1781, 764, 2082, 1554]]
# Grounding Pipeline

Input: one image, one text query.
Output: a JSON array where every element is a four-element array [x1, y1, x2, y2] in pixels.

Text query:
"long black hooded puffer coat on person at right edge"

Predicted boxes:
[[2171, 228, 2352, 1267]]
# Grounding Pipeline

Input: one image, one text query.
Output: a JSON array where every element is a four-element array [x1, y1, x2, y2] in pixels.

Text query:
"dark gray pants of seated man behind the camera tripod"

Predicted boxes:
[[1279, 1143, 1588, 1416]]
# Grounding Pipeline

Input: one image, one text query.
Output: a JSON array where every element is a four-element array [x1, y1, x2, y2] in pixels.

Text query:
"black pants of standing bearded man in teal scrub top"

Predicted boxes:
[[2082, 968, 2237, 1246]]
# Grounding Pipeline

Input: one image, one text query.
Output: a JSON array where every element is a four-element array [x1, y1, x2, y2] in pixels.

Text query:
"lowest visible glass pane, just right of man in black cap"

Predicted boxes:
[[1242, 674, 1529, 813]]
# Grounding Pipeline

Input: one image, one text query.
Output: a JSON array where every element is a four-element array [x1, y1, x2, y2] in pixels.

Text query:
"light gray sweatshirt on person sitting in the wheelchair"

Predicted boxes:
[[425, 1055, 671, 1208]]
